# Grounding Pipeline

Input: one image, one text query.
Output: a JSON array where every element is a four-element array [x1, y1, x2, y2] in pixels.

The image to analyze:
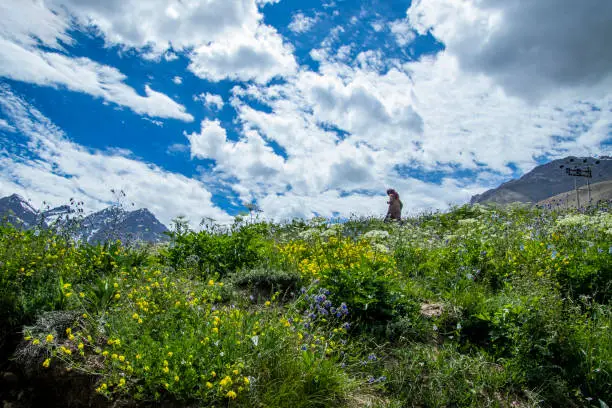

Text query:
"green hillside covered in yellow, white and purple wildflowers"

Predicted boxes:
[[0, 206, 612, 407]]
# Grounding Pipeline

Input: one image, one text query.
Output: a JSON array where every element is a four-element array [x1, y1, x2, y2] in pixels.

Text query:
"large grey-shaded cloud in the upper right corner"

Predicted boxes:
[[408, 0, 612, 100]]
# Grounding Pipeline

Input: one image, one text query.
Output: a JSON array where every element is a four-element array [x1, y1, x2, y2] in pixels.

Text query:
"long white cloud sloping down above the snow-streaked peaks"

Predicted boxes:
[[0, 86, 231, 225]]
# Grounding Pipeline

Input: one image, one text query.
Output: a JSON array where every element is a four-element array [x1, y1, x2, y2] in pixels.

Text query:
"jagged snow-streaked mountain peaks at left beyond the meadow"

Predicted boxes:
[[0, 194, 169, 244]]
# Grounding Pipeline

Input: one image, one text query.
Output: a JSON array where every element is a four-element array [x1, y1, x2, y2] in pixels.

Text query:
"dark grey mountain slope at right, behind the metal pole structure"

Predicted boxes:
[[470, 156, 612, 204]]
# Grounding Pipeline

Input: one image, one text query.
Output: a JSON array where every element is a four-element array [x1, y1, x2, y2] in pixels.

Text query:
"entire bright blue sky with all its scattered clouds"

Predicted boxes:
[[0, 0, 612, 224]]
